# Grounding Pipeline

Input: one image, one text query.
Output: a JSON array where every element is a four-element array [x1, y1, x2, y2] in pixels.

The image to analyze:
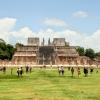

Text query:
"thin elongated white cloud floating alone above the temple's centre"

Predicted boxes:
[[42, 18, 68, 27]]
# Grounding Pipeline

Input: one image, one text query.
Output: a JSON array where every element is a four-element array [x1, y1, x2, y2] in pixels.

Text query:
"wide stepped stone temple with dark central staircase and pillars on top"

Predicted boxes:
[[2, 38, 100, 67]]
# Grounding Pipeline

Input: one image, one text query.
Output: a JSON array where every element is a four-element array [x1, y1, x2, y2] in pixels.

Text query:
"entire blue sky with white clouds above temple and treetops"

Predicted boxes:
[[0, 0, 100, 51]]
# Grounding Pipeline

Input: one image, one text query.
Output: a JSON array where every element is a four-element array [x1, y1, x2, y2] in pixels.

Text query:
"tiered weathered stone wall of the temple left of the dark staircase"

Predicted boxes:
[[12, 46, 38, 65]]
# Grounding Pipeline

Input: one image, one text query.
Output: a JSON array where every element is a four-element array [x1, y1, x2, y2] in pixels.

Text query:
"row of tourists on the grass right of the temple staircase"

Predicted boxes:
[[58, 66, 98, 77]]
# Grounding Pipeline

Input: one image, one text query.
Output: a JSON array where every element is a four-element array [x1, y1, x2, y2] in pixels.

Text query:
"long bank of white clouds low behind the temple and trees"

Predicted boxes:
[[0, 17, 100, 52]]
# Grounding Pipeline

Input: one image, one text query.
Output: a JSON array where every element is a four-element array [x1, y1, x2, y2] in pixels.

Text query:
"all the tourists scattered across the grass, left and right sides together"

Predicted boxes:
[[0, 65, 99, 77]]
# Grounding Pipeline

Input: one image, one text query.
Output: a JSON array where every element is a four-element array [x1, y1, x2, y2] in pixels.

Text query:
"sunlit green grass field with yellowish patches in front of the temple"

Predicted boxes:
[[0, 68, 100, 100]]
